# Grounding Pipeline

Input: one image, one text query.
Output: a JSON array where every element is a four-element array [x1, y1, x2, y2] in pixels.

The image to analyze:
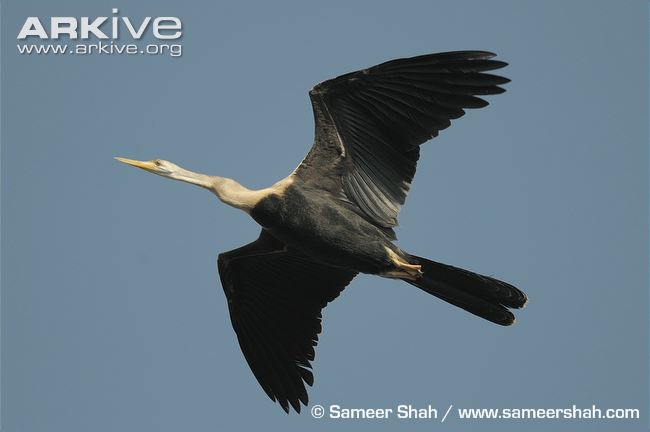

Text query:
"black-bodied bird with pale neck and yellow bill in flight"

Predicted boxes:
[[116, 51, 527, 413]]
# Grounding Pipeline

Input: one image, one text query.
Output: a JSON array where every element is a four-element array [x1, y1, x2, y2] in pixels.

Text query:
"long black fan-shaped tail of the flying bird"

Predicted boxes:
[[403, 255, 528, 326]]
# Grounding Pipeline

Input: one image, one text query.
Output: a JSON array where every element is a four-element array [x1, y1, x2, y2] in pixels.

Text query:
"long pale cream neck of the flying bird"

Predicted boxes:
[[170, 169, 293, 213]]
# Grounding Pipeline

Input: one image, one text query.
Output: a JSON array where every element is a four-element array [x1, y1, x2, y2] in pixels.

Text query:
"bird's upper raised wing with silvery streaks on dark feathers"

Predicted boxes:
[[295, 51, 509, 227]]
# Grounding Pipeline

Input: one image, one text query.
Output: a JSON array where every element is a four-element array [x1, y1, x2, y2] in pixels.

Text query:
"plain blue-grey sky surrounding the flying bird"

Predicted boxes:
[[1, 0, 648, 432]]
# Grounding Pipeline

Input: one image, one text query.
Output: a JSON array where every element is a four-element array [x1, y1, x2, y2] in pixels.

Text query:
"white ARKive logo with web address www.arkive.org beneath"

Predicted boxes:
[[16, 8, 183, 57]]
